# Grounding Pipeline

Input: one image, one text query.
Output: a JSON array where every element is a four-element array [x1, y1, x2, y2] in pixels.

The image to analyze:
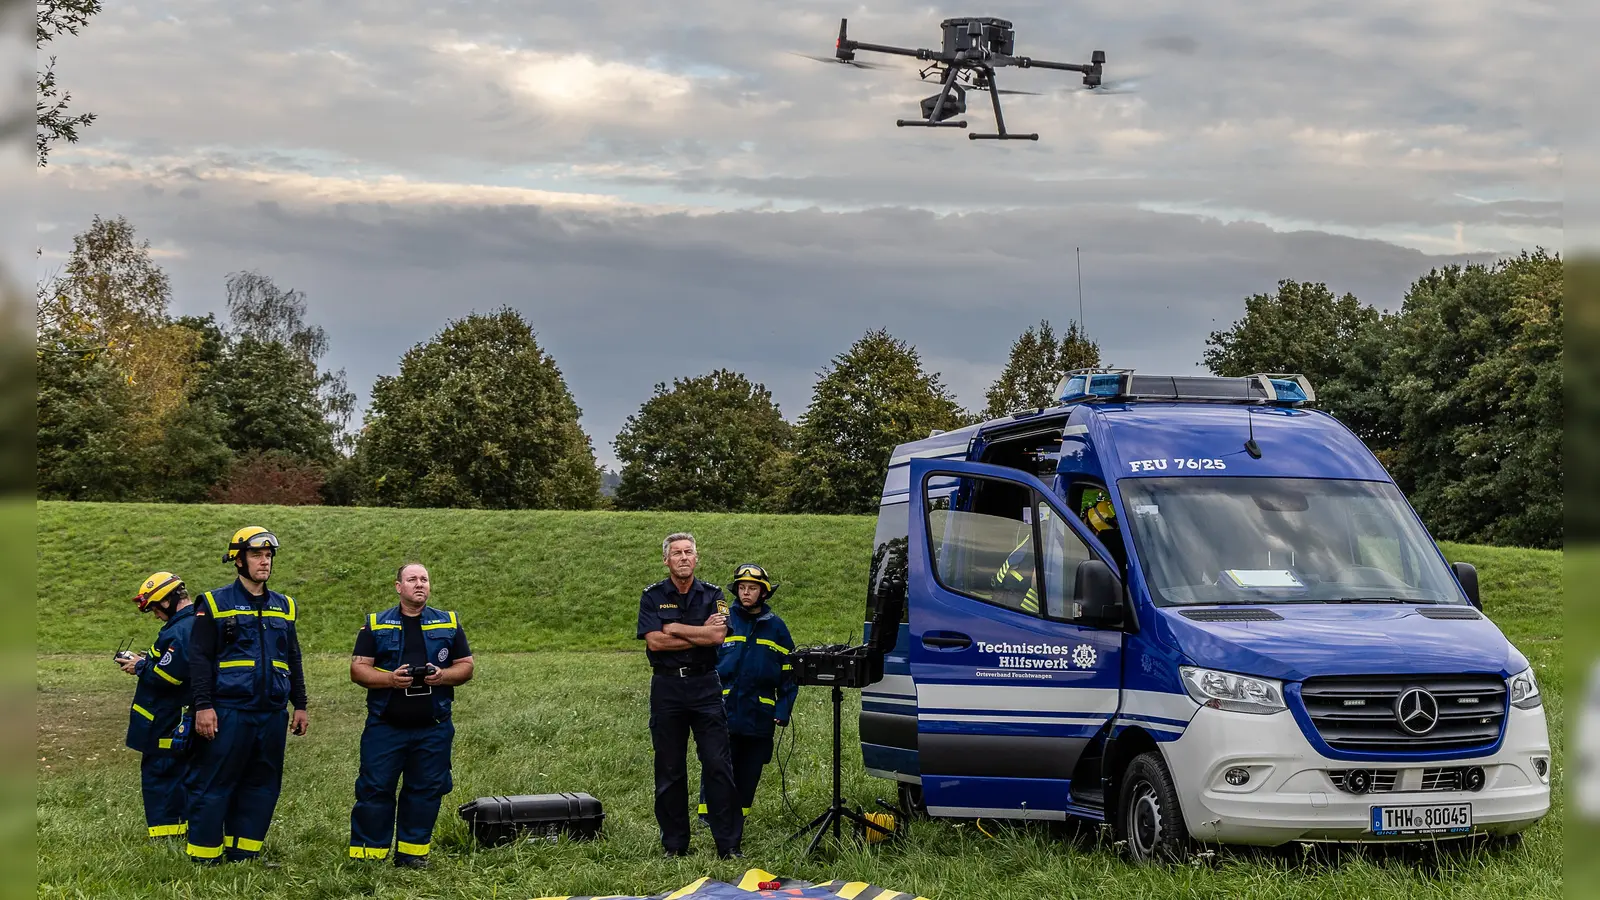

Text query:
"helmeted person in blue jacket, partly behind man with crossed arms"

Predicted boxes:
[[699, 562, 800, 815]]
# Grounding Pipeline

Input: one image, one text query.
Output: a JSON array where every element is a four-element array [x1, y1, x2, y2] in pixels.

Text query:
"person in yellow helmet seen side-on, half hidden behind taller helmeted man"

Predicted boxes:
[[117, 572, 195, 838]]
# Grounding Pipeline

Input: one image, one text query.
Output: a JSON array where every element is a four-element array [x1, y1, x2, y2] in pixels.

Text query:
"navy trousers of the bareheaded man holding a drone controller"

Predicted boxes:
[[350, 717, 456, 858]]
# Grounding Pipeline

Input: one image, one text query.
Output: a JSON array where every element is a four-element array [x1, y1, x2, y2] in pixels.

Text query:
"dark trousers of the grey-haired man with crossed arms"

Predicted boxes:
[[650, 671, 744, 852]]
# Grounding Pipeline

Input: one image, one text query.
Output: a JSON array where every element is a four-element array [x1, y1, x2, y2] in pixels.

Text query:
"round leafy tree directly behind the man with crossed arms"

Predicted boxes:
[[614, 368, 790, 512]]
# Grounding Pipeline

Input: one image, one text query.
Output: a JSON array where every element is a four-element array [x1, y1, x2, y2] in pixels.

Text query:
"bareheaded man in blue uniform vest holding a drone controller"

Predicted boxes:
[[350, 562, 472, 868]]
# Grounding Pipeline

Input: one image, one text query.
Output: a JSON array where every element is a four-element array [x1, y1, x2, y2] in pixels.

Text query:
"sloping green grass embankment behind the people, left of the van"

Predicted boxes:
[[35, 503, 874, 653]]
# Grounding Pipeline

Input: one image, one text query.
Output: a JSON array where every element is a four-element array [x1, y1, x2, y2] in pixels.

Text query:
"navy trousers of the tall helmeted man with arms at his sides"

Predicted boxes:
[[186, 708, 290, 862]]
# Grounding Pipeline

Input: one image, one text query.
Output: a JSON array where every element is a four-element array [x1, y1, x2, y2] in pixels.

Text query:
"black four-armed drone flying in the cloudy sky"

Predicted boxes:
[[811, 16, 1120, 141]]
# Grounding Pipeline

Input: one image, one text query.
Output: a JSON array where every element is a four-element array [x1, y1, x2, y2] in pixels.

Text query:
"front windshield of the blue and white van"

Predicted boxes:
[[1118, 477, 1467, 605]]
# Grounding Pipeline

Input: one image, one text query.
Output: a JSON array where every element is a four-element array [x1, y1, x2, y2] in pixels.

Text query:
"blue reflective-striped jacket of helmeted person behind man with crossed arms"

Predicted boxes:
[[717, 602, 800, 737]]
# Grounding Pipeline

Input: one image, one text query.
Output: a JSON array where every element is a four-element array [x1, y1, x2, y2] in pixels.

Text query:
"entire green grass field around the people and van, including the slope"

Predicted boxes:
[[35, 503, 1565, 900]]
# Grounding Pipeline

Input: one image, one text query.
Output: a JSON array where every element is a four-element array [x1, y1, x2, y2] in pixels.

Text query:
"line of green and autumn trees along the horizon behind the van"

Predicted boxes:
[[35, 218, 1562, 546]]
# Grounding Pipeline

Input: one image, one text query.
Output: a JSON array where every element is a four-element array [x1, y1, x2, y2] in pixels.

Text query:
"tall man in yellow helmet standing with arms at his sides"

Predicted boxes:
[[187, 525, 309, 863]]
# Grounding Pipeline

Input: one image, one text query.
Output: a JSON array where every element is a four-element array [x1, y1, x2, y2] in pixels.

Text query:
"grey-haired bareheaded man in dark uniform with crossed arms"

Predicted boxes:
[[637, 533, 744, 858]]
